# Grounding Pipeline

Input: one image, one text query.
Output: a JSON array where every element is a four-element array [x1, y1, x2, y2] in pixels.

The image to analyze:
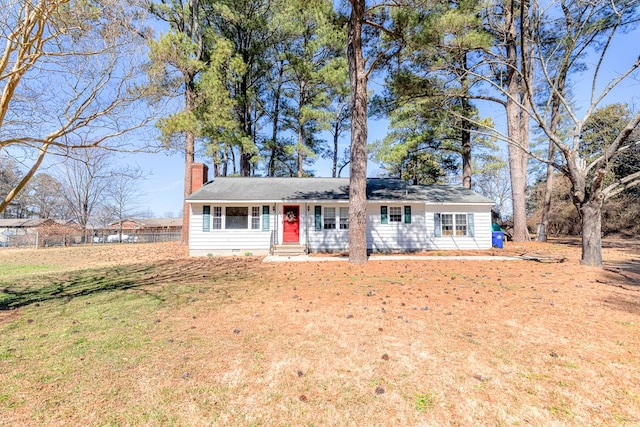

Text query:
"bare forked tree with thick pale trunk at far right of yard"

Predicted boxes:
[[523, 0, 640, 266]]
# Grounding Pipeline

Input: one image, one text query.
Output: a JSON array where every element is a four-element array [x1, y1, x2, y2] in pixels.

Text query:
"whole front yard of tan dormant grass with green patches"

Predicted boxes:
[[0, 239, 640, 426]]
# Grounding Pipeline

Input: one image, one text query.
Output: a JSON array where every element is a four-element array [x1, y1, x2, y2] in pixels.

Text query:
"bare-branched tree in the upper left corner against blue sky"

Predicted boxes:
[[0, 0, 158, 212]]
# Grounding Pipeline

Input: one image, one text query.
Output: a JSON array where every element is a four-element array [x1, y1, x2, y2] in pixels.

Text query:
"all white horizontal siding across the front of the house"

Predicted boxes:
[[189, 202, 491, 255]]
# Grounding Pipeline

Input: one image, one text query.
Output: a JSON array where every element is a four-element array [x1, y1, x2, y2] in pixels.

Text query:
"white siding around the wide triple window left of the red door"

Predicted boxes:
[[189, 203, 275, 256]]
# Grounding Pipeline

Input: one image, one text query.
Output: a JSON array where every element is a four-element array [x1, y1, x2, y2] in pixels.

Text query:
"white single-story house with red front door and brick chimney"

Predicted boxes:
[[186, 165, 494, 256]]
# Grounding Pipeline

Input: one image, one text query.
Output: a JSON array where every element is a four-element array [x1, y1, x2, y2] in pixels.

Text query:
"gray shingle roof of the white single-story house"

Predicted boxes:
[[187, 177, 493, 204]]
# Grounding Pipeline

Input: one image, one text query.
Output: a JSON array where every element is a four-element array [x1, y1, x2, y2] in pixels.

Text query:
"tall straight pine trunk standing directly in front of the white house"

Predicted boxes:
[[347, 0, 367, 264]]
